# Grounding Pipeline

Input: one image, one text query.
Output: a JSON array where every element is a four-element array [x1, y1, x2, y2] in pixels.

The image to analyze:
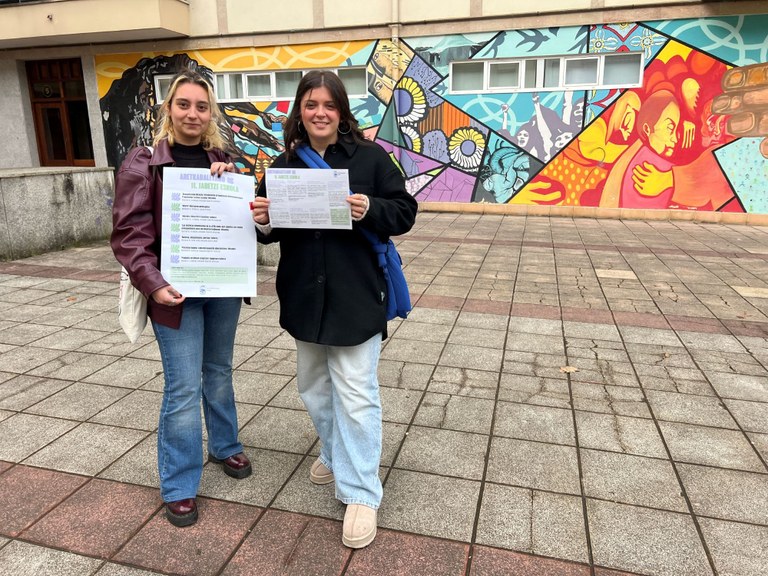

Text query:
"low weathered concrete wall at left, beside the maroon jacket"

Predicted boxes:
[[0, 168, 114, 259]]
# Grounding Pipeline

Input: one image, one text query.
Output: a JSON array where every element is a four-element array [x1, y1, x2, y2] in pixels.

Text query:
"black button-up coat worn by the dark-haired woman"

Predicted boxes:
[[258, 140, 418, 346]]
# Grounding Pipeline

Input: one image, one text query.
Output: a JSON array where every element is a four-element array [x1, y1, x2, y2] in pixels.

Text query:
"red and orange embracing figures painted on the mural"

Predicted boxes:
[[600, 52, 742, 211]]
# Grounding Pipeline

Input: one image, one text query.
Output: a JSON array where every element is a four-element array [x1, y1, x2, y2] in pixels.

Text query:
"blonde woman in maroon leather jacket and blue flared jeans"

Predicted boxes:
[[111, 70, 251, 527]]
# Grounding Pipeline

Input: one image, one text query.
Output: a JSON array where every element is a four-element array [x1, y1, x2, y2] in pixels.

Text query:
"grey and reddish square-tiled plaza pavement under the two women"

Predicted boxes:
[[0, 212, 768, 576]]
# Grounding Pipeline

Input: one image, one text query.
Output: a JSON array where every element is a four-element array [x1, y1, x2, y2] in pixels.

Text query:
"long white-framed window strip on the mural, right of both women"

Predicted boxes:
[[450, 52, 643, 93]]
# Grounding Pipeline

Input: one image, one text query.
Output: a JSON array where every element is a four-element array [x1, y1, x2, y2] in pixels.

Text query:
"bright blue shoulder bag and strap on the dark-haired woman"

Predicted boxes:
[[296, 144, 411, 320]]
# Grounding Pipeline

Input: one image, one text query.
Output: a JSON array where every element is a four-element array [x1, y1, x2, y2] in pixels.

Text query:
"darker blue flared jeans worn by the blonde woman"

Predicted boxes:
[[152, 298, 243, 502]]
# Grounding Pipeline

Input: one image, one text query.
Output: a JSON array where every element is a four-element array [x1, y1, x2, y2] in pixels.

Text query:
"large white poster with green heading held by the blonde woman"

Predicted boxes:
[[160, 168, 257, 297]]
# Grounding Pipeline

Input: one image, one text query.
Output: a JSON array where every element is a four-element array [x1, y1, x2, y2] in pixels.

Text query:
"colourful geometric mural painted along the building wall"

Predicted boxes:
[[96, 14, 768, 213]]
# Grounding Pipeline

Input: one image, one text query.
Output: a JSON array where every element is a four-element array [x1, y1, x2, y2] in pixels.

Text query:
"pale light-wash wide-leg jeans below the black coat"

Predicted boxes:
[[296, 334, 382, 509]]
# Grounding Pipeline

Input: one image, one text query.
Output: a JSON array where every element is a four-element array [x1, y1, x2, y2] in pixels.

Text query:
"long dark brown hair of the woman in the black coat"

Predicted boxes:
[[283, 70, 365, 157]]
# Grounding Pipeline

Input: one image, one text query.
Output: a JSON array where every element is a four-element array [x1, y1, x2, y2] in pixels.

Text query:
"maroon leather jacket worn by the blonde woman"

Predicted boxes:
[[110, 140, 232, 328]]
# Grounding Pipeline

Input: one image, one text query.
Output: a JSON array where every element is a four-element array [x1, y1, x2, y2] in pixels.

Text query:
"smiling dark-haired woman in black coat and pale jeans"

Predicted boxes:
[[253, 70, 417, 548]]
